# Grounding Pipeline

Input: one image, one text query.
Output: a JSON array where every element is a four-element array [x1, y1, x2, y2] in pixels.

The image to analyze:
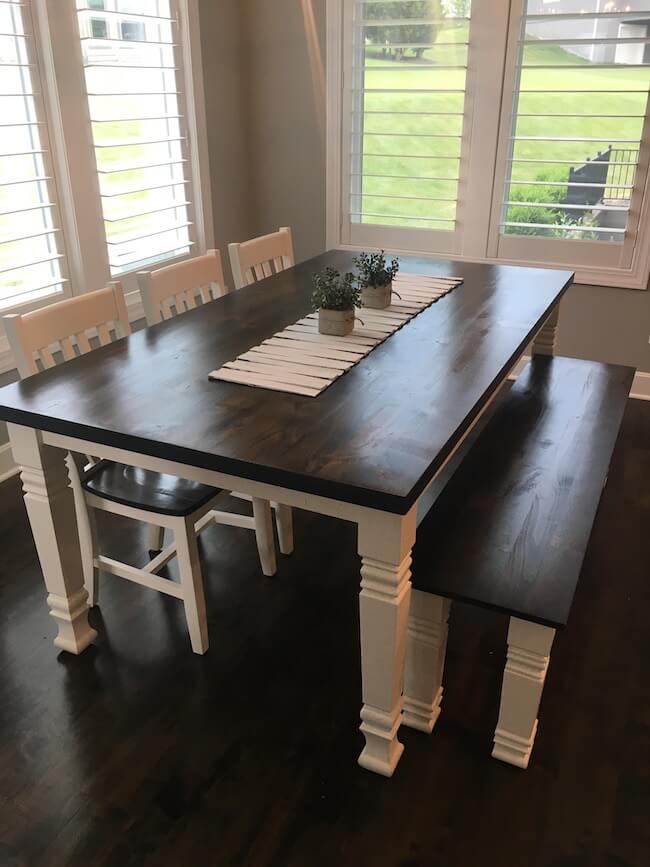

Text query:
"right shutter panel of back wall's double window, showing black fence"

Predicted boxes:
[[489, 0, 650, 271]]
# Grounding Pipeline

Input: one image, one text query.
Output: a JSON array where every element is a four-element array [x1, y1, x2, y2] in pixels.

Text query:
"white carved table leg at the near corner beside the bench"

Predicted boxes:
[[359, 509, 416, 777]]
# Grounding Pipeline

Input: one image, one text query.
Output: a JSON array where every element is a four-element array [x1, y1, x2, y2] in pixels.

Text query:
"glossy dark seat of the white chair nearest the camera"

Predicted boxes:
[[81, 461, 220, 517]]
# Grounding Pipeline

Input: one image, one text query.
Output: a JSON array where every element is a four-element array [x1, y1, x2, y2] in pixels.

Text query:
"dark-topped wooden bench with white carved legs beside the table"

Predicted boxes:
[[404, 356, 634, 768]]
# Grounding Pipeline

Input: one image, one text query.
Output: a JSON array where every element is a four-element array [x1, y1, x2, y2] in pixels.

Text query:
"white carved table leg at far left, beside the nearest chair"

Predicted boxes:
[[8, 424, 97, 654]]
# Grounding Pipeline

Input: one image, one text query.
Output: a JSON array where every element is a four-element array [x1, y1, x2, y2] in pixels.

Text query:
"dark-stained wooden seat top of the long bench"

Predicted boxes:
[[413, 357, 634, 628]]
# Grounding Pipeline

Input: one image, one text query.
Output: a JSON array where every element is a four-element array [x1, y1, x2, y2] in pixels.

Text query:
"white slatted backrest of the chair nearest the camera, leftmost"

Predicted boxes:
[[2, 283, 131, 379]]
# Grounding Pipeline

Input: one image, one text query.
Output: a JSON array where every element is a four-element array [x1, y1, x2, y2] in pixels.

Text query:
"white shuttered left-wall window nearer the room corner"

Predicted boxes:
[[77, 0, 195, 275]]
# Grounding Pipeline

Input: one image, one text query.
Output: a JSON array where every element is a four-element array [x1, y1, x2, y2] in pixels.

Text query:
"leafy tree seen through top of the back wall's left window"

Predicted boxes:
[[366, 0, 442, 59]]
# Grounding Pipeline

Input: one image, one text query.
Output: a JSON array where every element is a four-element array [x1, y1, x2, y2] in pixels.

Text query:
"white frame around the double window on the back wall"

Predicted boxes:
[[326, 0, 650, 290]]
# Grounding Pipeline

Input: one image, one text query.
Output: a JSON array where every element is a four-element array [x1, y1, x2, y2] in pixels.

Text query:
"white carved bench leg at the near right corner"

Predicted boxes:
[[492, 617, 555, 768]]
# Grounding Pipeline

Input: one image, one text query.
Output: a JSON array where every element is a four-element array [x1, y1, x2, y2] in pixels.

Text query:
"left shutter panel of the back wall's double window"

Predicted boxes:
[[342, 0, 471, 252]]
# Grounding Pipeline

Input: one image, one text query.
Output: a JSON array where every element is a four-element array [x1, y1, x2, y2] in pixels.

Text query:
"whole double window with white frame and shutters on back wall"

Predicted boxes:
[[328, 0, 650, 288]]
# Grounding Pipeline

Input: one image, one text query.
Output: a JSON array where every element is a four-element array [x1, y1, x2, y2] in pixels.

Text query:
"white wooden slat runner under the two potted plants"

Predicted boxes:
[[210, 274, 463, 397]]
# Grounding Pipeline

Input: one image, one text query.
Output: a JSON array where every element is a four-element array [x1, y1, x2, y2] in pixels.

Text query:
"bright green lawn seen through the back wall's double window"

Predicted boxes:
[[353, 33, 650, 229]]
